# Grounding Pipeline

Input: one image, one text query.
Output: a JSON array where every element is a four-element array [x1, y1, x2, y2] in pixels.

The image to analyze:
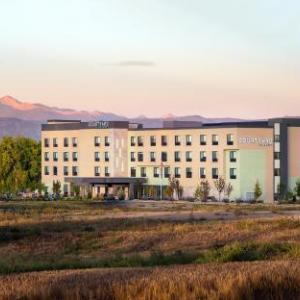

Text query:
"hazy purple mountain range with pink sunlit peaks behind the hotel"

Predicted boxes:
[[0, 96, 242, 139]]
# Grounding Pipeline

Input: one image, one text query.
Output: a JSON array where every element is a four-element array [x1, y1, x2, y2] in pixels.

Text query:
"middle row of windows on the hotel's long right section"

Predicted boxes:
[[130, 151, 237, 162]]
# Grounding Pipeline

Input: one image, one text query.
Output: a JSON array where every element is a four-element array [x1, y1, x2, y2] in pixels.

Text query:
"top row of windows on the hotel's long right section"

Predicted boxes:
[[130, 134, 234, 146]]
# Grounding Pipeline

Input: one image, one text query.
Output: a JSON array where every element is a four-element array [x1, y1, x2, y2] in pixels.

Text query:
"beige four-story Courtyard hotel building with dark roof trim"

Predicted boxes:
[[41, 118, 300, 202]]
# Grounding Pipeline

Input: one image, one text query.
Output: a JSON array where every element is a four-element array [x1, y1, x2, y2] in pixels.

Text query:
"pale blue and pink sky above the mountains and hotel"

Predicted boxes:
[[0, 0, 300, 119]]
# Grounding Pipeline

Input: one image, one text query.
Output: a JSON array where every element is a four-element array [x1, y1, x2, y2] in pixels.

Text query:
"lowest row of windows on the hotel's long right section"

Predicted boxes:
[[130, 167, 237, 179]]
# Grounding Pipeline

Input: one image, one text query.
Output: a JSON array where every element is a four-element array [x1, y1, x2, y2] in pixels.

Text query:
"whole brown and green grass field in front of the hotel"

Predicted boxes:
[[0, 201, 300, 299]]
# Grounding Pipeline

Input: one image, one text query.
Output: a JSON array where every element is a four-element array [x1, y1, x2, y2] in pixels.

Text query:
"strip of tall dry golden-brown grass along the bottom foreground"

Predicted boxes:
[[0, 261, 300, 300]]
